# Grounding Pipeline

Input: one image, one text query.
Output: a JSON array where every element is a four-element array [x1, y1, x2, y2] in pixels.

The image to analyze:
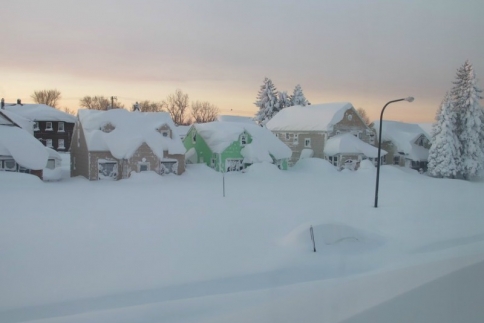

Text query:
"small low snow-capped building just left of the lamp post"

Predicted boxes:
[[324, 133, 387, 170]]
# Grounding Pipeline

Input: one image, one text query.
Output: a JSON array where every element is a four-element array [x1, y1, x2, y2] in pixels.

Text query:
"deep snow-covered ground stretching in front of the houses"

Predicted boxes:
[[0, 155, 484, 323]]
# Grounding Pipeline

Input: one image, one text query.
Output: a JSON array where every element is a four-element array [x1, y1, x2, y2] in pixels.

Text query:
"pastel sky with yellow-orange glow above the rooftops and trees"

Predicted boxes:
[[0, 0, 484, 122]]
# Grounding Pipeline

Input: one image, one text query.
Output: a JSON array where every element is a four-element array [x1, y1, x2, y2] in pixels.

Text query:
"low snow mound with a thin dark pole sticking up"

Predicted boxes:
[[283, 223, 385, 254]]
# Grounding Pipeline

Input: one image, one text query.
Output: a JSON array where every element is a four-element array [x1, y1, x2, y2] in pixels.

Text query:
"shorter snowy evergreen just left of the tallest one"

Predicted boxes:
[[428, 93, 460, 178]]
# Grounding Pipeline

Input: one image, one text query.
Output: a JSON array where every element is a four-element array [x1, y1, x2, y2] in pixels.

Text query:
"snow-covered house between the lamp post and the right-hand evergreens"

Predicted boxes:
[[374, 121, 430, 170]]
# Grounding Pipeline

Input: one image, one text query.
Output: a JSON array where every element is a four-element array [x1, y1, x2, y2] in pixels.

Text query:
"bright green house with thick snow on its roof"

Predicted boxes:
[[183, 121, 291, 172]]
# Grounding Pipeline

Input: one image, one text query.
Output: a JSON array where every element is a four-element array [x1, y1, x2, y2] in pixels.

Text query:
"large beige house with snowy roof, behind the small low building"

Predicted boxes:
[[266, 102, 375, 167]]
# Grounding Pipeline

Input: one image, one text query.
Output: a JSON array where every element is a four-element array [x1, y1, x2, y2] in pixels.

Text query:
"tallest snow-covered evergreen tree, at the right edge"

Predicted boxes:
[[451, 61, 484, 179]]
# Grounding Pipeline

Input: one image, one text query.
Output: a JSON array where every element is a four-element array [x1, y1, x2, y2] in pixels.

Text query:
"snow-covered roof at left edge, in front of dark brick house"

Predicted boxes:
[[0, 125, 49, 170]]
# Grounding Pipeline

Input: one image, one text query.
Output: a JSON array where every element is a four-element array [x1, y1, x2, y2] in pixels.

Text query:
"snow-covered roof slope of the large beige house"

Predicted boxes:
[[266, 102, 353, 131]]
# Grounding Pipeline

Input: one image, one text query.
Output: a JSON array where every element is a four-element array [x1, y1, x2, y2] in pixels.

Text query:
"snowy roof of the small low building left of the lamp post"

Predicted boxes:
[[324, 133, 387, 158]]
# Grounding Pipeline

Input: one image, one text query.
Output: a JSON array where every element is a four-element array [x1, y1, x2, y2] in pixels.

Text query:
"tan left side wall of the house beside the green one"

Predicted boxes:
[[70, 121, 90, 179]]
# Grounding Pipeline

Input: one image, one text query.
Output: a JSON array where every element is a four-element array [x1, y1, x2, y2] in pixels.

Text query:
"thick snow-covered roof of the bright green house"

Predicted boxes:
[[193, 121, 292, 163]]
